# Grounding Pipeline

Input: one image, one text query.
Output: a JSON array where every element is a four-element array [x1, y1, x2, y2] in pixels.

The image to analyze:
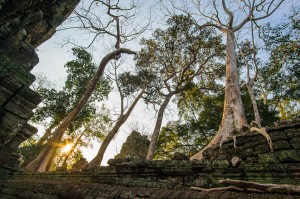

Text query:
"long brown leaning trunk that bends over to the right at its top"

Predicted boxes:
[[26, 48, 136, 172]]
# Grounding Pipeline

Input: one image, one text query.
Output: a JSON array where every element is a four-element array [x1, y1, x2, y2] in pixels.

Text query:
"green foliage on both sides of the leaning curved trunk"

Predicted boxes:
[[32, 48, 111, 132]]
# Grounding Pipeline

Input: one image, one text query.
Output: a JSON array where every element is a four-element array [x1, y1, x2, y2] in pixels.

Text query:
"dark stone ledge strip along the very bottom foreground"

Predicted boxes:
[[0, 179, 299, 199]]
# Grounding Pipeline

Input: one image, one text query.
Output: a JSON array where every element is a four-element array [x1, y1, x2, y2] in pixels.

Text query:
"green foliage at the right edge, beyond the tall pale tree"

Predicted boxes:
[[260, 9, 300, 119]]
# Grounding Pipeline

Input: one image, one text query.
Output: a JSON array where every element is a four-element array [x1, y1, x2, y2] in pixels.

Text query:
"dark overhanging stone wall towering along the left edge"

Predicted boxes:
[[0, 0, 79, 178]]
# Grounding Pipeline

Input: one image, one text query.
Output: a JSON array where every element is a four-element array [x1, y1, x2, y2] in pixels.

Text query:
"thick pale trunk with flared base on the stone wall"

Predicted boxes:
[[190, 30, 247, 160]]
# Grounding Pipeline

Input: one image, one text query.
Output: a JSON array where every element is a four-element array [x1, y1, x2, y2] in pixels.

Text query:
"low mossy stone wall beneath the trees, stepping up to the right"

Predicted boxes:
[[0, 121, 300, 198]]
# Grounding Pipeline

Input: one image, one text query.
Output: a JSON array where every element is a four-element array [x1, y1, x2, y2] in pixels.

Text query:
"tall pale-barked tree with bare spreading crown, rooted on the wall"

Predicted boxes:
[[166, 0, 283, 159]]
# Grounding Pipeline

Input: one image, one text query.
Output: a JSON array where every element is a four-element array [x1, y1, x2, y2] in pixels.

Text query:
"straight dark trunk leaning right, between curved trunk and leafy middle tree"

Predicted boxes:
[[88, 90, 144, 168]]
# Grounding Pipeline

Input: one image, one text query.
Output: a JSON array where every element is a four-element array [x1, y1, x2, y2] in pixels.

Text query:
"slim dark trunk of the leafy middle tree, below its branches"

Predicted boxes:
[[146, 94, 173, 160]]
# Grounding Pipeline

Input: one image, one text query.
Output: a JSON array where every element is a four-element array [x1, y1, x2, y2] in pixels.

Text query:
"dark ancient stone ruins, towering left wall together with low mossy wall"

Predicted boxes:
[[0, 0, 300, 199]]
